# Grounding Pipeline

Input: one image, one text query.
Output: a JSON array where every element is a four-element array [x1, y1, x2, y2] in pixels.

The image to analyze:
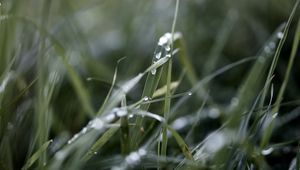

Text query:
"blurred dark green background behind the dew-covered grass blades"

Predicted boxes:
[[0, 0, 300, 169]]
